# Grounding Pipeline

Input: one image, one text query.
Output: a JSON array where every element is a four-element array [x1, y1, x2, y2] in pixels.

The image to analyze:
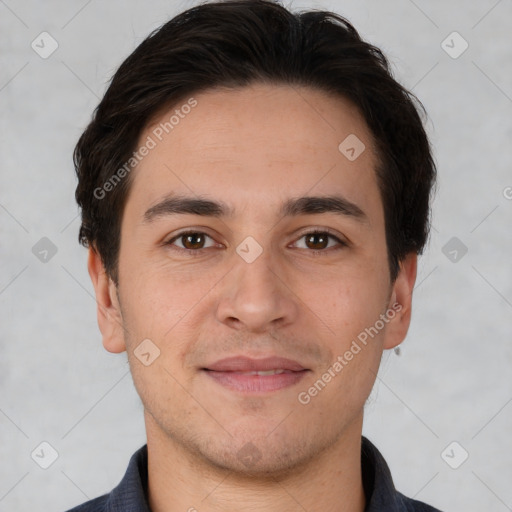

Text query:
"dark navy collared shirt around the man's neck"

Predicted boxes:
[[67, 436, 440, 512]]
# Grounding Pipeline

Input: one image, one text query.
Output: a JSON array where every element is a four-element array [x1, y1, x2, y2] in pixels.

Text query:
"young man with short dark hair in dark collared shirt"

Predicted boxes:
[[64, 0, 435, 512]]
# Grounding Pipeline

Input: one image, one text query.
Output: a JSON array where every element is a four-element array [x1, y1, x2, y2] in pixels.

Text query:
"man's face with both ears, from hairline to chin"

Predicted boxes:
[[89, 85, 416, 474]]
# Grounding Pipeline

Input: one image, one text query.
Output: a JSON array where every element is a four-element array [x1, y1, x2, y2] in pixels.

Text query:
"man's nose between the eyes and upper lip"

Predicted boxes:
[[217, 247, 299, 333]]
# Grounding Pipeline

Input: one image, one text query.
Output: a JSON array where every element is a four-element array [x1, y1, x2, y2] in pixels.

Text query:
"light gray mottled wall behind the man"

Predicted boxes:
[[0, 0, 512, 512]]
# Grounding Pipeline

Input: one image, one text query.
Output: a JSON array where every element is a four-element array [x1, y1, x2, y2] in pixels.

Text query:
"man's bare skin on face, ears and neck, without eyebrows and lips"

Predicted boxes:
[[88, 84, 417, 512]]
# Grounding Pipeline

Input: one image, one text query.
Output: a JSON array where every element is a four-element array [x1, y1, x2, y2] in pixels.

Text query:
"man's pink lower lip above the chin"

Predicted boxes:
[[204, 370, 309, 393]]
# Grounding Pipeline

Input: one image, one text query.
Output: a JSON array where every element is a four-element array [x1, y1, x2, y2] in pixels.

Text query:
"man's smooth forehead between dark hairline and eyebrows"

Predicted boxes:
[[126, 84, 380, 224]]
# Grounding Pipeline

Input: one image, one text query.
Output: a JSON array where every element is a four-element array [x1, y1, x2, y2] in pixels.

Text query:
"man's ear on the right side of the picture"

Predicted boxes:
[[384, 252, 418, 349]]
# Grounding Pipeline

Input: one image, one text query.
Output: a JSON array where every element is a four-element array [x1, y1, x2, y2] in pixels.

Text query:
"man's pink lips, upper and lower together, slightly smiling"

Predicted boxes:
[[202, 356, 309, 394]]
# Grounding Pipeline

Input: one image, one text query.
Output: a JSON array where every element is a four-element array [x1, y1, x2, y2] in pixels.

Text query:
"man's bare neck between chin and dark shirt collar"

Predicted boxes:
[[145, 412, 365, 512]]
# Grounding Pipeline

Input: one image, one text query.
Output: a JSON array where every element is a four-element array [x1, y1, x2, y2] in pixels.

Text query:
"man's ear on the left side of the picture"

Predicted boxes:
[[87, 246, 126, 353]]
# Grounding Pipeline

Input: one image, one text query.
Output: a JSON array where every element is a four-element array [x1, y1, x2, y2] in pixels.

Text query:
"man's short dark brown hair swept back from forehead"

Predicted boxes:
[[74, 0, 436, 283]]
